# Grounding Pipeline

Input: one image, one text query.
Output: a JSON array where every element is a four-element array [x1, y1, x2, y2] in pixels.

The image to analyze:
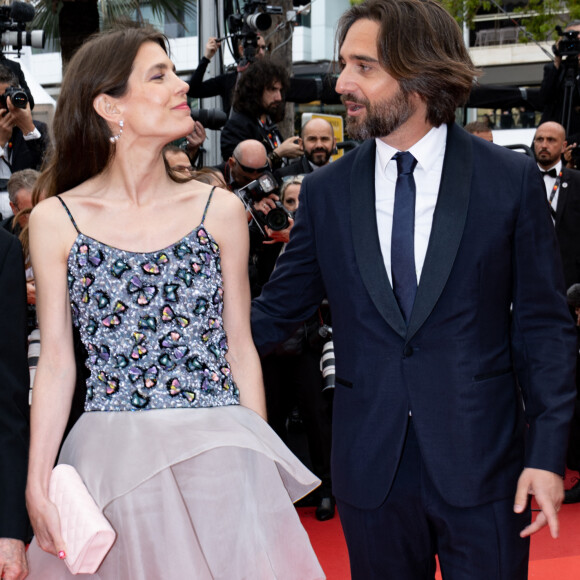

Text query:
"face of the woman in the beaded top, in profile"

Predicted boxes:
[[119, 42, 194, 144]]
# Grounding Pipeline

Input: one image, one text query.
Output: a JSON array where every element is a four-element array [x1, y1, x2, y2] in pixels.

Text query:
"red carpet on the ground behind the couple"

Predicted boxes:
[[298, 474, 580, 580]]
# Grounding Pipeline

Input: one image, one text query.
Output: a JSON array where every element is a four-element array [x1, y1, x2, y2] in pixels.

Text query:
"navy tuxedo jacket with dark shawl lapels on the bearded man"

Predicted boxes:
[[252, 125, 576, 509]]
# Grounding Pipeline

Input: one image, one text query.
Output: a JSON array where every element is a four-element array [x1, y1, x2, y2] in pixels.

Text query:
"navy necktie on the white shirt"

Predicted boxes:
[[391, 151, 417, 324]]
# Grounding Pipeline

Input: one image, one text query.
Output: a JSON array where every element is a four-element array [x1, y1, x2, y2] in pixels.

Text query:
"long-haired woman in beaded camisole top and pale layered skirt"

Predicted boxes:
[[27, 28, 324, 580]]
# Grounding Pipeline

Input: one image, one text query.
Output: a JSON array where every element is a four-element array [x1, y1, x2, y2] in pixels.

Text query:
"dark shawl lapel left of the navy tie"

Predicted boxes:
[[350, 139, 407, 337]]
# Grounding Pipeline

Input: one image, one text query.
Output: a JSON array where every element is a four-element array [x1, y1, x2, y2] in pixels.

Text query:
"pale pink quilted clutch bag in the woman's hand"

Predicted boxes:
[[48, 464, 116, 574]]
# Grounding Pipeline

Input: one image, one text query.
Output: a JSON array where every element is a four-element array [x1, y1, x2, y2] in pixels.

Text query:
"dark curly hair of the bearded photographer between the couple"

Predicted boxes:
[[232, 58, 290, 118]]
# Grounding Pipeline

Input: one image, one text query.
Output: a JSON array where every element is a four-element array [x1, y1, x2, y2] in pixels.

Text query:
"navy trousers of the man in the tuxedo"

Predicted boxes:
[[337, 420, 531, 580]]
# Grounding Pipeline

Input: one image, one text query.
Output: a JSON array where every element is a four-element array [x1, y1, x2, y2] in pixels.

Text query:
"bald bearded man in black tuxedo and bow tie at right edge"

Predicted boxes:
[[534, 121, 580, 288]]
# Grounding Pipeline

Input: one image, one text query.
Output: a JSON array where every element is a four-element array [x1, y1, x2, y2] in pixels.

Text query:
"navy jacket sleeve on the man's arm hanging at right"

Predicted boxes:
[[512, 156, 576, 473]]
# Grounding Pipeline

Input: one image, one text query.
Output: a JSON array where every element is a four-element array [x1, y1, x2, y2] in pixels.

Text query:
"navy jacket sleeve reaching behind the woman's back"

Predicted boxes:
[[252, 179, 326, 354]]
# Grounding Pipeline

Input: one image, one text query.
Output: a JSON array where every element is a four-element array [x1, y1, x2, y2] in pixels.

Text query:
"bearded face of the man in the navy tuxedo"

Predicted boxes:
[[336, 19, 418, 139]]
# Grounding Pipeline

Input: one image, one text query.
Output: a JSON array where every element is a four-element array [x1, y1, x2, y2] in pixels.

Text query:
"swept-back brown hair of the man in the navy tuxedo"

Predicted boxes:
[[337, 0, 479, 127]]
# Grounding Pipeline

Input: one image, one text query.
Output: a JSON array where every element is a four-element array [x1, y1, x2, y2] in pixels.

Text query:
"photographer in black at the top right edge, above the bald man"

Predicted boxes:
[[539, 20, 580, 135]]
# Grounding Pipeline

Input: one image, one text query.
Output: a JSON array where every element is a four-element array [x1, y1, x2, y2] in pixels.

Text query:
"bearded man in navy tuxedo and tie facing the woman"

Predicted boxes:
[[252, 0, 575, 580]]
